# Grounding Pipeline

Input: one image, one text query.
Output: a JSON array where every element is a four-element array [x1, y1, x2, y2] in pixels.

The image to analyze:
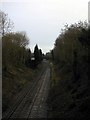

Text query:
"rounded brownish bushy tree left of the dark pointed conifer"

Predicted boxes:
[[2, 33, 30, 70]]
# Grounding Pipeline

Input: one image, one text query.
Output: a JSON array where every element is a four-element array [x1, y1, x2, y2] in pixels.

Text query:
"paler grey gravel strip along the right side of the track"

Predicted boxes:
[[28, 69, 50, 118]]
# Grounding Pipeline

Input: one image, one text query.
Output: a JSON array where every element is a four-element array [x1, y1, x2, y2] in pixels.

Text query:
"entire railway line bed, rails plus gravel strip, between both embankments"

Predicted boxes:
[[3, 63, 50, 120]]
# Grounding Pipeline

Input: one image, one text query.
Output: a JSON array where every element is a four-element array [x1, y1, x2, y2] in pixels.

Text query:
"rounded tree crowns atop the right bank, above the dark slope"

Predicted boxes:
[[51, 22, 90, 80]]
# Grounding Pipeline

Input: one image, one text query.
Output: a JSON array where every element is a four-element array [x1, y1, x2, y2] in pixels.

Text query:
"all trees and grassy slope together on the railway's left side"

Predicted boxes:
[[0, 11, 42, 112]]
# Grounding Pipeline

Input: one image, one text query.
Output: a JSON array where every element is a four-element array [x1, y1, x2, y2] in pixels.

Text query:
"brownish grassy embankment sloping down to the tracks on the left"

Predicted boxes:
[[2, 64, 42, 112]]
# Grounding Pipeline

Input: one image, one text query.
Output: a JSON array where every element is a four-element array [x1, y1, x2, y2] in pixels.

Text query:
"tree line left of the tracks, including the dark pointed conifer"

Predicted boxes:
[[0, 11, 43, 70]]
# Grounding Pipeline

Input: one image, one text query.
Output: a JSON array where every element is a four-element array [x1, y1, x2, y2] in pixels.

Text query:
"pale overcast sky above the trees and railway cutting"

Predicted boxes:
[[0, 0, 89, 53]]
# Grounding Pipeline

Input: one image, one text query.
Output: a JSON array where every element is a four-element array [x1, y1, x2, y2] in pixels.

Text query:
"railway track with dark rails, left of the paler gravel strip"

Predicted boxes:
[[3, 63, 49, 120]]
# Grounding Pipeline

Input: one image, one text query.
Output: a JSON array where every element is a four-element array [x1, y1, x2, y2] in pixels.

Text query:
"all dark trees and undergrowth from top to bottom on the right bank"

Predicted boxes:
[[48, 22, 90, 120]]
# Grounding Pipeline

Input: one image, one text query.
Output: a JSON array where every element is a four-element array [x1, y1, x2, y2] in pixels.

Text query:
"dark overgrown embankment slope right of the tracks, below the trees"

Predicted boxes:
[[48, 64, 90, 120]]
